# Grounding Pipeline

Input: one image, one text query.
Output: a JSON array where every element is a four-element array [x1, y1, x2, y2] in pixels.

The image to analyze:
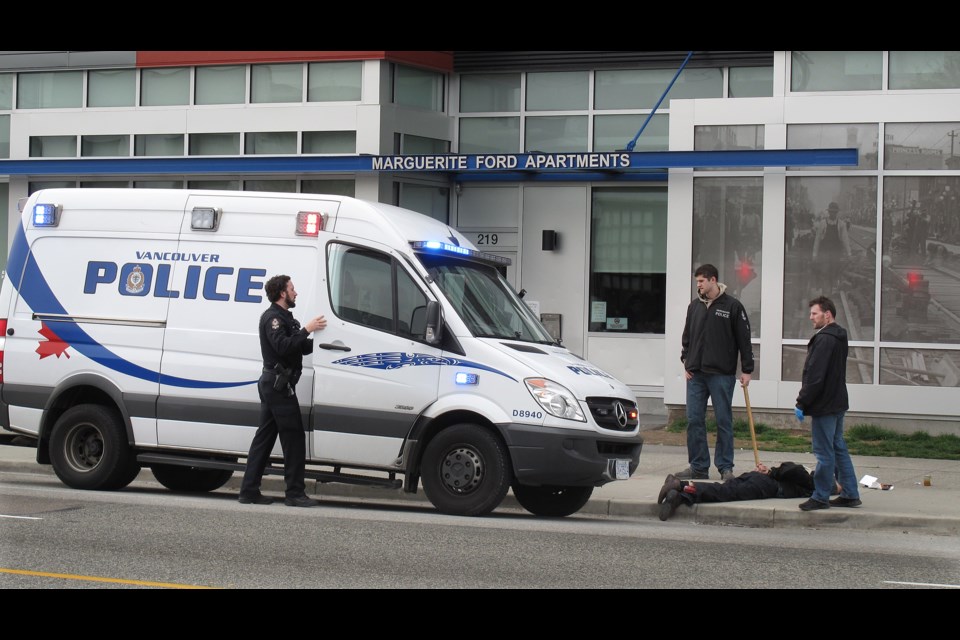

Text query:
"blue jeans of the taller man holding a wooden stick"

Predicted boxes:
[[687, 371, 737, 473]]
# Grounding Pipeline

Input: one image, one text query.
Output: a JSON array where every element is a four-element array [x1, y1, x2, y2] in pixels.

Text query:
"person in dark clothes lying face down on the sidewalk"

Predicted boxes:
[[657, 462, 813, 520]]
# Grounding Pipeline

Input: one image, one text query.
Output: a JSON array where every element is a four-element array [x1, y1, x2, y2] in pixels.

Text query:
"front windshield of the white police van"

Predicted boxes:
[[417, 253, 556, 344]]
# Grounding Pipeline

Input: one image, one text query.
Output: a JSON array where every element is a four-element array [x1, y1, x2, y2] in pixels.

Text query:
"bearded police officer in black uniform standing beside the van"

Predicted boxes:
[[240, 275, 327, 507]]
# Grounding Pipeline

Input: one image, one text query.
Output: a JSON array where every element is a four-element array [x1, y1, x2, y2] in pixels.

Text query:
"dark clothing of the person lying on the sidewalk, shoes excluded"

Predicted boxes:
[[684, 462, 813, 503]]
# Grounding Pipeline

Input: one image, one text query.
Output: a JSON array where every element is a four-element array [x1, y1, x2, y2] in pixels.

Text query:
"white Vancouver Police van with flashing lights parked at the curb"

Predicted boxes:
[[0, 189, 643, 516]]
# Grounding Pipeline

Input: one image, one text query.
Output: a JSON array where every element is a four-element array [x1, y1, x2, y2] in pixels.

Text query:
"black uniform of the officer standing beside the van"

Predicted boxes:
[[240, 302, 313, 499]]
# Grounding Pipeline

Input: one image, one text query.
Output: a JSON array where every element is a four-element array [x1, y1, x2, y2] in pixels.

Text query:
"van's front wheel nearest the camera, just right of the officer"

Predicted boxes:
[[420, 424, 513, 516]]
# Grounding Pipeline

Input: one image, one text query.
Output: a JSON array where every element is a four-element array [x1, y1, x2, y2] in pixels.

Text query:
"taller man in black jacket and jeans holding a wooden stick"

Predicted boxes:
[[675, 264, 753, 480]]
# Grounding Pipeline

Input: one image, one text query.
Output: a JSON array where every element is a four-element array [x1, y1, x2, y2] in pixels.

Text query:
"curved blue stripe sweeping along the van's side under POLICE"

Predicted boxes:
[[7, 222, 257, 389]]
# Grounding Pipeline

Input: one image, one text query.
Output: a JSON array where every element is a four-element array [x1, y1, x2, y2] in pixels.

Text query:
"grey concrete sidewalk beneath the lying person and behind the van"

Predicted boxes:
[[0, 427, 960, 536]]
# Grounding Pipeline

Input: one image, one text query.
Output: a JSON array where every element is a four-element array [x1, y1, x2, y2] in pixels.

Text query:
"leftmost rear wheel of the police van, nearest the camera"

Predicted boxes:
[[50, 404, 140, 491]]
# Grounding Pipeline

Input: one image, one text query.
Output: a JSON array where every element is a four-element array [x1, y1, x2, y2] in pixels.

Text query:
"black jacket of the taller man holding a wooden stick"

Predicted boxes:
[[680, 286, 753, 376]]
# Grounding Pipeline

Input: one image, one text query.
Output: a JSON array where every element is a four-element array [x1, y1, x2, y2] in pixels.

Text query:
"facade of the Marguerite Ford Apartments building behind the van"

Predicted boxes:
[[0, 51, 960, 432]]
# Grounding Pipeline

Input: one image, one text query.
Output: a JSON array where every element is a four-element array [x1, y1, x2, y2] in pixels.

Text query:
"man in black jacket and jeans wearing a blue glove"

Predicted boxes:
[[794, 296, 862, 511]]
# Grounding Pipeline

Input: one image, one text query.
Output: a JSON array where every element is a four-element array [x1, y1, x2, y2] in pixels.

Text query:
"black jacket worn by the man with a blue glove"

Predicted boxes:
[[797, 322, 850, 416]]
